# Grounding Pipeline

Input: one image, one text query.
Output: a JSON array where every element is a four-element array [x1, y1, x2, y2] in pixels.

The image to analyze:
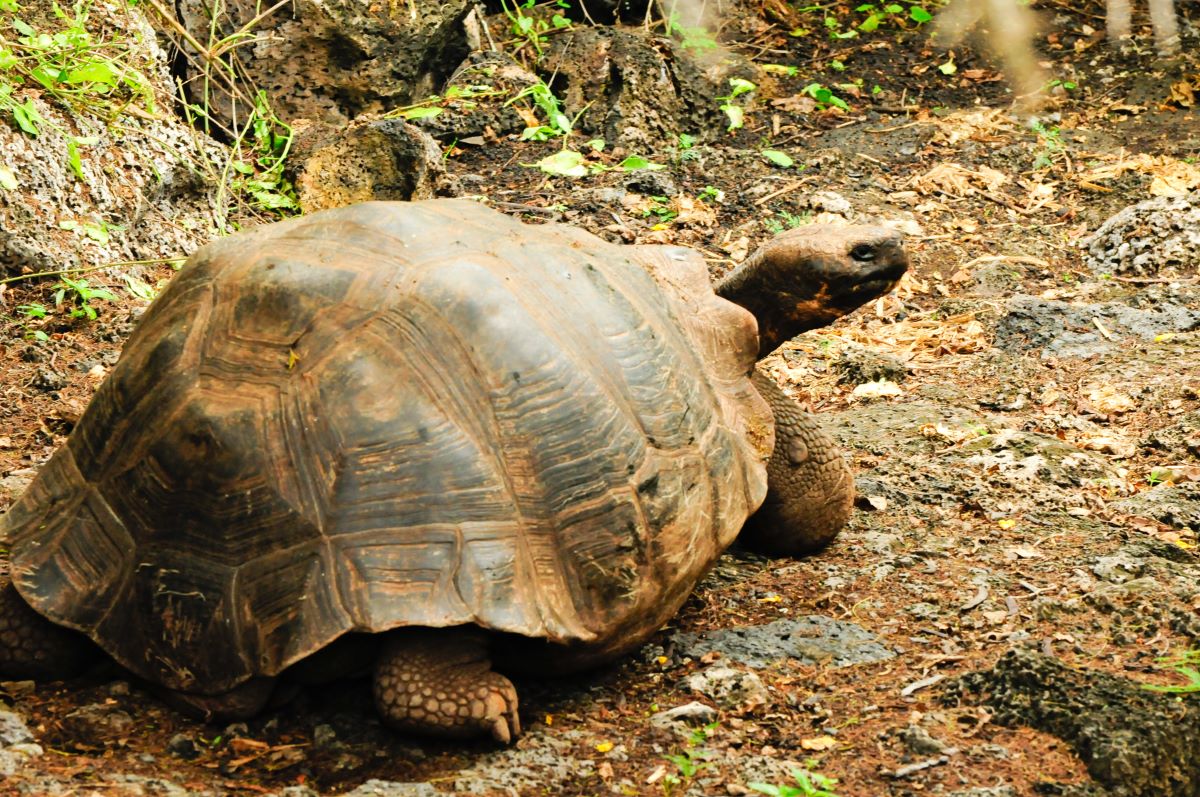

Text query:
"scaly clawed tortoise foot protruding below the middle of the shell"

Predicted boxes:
[[374, 628, 521, 744]]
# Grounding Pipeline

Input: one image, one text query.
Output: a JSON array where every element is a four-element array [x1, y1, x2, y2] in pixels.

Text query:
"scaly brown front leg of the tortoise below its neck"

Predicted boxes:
[[740, 371, 854, 556]]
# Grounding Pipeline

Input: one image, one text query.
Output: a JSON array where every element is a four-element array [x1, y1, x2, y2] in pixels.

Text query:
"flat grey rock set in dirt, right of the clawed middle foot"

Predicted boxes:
[[672, 615, 895, 669]]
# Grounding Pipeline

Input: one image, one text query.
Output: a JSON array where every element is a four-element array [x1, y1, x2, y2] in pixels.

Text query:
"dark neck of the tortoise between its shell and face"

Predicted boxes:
[[716, 248, 853, 360]]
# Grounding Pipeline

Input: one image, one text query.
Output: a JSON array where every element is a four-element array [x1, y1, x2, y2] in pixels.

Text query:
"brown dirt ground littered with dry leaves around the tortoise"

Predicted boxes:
[[0, 2, 1200, 797]]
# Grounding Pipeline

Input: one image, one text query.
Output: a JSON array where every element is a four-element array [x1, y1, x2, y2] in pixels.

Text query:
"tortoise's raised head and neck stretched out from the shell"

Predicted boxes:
[[716, 224, 908, 356]]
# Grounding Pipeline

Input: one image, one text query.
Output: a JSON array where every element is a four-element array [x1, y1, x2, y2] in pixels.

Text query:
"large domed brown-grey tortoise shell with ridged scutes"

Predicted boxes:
[[0, 200, 773, 693]]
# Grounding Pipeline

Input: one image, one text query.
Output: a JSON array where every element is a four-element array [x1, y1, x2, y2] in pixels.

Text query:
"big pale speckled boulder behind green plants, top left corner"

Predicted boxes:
[[0, 6, 224, 279]]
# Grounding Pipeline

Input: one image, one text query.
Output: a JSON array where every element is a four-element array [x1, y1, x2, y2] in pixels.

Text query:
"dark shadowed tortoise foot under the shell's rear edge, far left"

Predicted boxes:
[[0, 579, 100, 681]]
